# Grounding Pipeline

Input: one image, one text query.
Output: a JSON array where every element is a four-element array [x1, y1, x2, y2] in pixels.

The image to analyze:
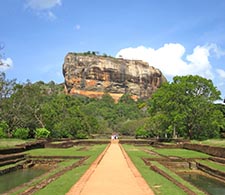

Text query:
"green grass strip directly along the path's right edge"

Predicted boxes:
[[123, 144, 186, 195]]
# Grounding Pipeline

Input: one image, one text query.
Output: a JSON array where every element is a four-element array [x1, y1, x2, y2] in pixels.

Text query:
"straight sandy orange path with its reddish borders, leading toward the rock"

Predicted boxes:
[[66, 140, 154, 195]]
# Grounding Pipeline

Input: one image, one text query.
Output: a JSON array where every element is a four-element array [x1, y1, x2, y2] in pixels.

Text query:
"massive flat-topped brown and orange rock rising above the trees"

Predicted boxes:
[[63, 53, 166, 101]]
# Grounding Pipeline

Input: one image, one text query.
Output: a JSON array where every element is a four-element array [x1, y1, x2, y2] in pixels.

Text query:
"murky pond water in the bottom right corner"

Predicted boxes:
[[180, 173, 225, 195]]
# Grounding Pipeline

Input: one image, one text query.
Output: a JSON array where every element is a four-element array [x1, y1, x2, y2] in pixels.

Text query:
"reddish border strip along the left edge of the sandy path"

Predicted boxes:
[[66, 144, 110, 195]]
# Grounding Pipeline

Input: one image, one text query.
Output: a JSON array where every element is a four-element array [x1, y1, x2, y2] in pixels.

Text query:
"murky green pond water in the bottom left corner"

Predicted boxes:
[[0, 168, 46, 194]]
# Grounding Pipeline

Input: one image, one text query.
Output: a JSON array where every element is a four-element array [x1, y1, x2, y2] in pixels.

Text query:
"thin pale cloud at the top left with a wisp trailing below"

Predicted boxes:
[[25, 0, 62, 21]]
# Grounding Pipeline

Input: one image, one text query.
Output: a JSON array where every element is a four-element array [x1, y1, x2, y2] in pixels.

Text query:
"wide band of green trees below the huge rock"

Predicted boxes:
[[0, 72, 225, 140]]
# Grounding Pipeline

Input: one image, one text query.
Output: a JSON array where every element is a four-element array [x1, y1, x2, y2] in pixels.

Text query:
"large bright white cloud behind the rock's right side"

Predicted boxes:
[[116, 43, 216, 79]]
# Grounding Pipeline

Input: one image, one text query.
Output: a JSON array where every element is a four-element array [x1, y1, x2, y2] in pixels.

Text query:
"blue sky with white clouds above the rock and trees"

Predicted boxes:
[[0, 0, 225, 98]]
